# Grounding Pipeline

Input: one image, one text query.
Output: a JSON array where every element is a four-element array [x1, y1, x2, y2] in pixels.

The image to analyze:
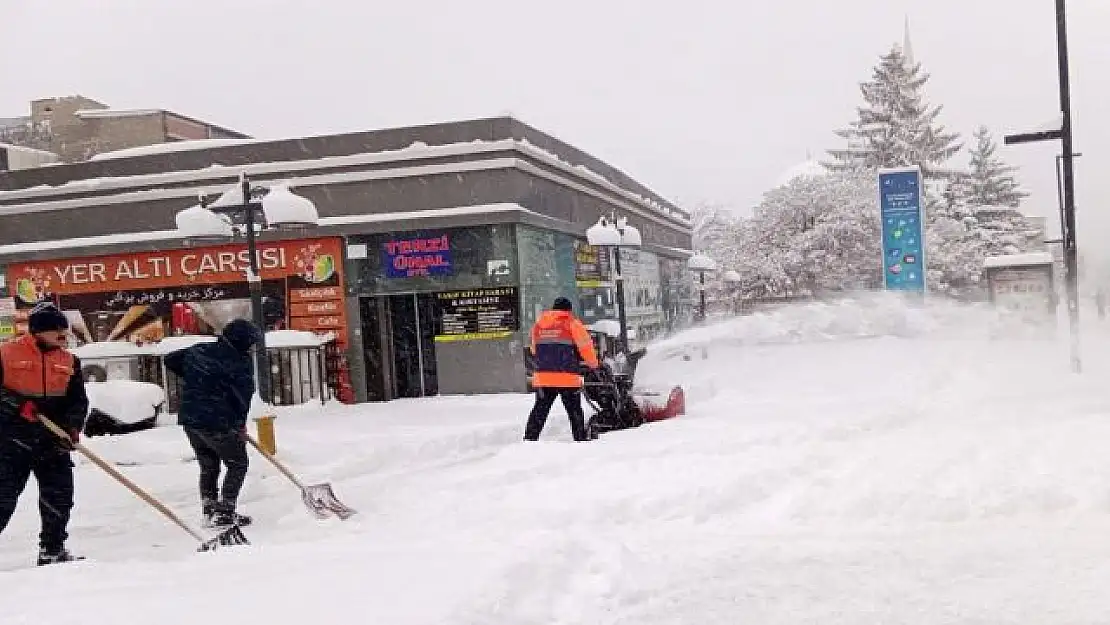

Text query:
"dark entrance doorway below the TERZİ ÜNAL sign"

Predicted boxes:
[[362, 293, 440, 401]]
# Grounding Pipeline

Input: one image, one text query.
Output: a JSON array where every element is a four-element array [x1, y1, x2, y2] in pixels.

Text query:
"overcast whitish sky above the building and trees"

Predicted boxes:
[[0, 0, 1110, 253]]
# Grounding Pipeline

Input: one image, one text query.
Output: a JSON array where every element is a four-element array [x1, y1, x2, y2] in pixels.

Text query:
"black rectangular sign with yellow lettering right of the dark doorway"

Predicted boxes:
[[435, 286, 521, 342]]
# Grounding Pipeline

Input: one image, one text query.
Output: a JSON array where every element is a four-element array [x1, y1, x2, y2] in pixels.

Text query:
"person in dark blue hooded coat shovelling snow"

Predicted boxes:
[[165, 319, 262, 526]]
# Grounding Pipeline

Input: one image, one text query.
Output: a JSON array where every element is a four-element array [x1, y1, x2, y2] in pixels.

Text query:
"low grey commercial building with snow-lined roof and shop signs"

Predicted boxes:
[[0, 118, 690, 401]]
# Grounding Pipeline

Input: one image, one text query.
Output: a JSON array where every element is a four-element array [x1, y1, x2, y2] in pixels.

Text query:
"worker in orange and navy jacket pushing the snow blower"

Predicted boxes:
[[524, 298, 598, 441]]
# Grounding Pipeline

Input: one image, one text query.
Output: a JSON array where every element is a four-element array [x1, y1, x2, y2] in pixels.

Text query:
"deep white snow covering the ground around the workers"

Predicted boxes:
[[0, 299, 1110, 625]]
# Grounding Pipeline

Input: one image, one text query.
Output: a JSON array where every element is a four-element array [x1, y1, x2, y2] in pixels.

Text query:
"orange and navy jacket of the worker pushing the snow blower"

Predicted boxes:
[[532, 311, 598, 389]]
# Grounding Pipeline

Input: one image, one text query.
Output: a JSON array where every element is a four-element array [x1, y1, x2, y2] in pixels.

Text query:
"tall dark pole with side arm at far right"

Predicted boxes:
[[1005, 0, 1082, 373]]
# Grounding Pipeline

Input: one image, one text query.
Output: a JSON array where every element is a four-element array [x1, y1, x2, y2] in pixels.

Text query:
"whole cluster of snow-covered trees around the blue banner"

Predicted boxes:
[[695, 40, 1043, 299]]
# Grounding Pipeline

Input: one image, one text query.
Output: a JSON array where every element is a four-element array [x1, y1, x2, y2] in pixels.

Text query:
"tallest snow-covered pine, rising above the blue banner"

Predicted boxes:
[[824, 46, 962, 179]]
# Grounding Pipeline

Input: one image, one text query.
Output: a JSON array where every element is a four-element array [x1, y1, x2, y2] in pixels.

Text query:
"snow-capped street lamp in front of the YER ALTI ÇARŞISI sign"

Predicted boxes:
[[178, 172, 320, 403]]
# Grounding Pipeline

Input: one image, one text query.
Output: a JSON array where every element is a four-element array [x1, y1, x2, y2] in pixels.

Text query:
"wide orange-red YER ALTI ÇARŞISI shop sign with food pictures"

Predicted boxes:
[[8, 238, 346, 344]]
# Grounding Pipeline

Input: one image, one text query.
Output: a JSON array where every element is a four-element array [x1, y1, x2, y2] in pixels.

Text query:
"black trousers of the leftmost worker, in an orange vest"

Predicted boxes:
[[0, 424, 73, 553]]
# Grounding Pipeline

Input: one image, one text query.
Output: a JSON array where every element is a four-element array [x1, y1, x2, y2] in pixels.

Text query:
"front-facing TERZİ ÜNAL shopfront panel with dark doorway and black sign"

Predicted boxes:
[[347, 225, 526, 401]]
